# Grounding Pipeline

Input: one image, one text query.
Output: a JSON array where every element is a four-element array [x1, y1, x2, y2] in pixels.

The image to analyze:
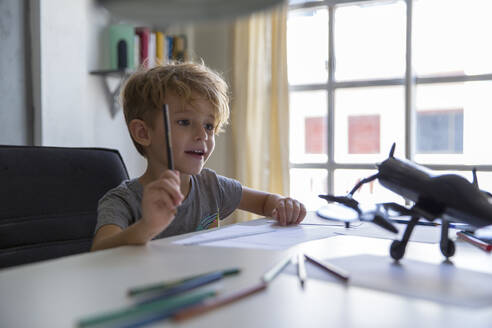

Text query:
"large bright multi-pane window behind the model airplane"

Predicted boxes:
[[287, 0, 492, 210]]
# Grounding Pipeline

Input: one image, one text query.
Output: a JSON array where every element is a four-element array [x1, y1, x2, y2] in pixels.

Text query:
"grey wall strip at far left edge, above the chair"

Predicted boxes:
[[0, 0, 32, 145]]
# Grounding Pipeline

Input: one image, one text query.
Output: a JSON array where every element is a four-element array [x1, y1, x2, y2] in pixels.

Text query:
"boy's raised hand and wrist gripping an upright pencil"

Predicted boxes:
[[142, 170, 184, 236]]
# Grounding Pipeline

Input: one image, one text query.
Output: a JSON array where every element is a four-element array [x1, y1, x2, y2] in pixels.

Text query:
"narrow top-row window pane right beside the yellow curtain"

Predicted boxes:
[[287, 8, 328, 84]]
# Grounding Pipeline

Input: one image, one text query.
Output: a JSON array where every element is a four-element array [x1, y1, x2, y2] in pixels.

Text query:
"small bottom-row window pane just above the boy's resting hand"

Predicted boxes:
[[290, 169, 328, 211]]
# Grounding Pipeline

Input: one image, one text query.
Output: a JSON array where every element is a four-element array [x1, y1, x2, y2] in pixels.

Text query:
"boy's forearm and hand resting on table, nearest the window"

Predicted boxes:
[[239, 186, 306, 225]]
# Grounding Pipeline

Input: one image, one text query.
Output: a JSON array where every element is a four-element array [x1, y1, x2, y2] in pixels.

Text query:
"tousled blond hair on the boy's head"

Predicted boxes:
[[121, 62, 229, 156]]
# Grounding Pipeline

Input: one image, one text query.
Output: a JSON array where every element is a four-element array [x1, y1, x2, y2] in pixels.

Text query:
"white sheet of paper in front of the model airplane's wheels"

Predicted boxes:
[[285, 254, 492, 308]]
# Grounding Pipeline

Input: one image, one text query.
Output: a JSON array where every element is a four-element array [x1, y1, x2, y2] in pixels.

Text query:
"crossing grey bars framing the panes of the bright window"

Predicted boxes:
[[289, 0, 492, 194]]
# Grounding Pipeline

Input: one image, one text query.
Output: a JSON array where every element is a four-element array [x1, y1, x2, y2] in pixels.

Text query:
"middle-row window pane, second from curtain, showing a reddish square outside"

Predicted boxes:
[[334, 86, 405, 163]]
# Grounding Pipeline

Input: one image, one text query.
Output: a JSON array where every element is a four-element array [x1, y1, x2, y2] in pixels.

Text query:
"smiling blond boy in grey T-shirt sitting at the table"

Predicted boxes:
[[92, 63, 306, 250]]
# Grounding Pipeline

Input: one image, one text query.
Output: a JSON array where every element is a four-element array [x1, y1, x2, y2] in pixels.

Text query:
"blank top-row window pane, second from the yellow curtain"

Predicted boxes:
[[334, 1, 406, 80]]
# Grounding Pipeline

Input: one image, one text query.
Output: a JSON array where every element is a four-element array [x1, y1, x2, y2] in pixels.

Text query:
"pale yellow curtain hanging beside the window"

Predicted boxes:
[[231, 6, 289, 221]]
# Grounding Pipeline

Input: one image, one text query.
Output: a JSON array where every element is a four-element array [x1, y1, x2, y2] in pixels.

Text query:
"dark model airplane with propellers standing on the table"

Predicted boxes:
[[320, 144, 492, 260]]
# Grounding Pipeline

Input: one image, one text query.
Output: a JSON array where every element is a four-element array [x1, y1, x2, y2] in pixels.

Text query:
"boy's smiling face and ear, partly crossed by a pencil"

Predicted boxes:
[[151, 94, 215, 175]]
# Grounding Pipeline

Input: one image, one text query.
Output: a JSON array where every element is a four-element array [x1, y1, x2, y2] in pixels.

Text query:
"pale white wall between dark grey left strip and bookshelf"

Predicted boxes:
[[31, 0, 145, 177]]
